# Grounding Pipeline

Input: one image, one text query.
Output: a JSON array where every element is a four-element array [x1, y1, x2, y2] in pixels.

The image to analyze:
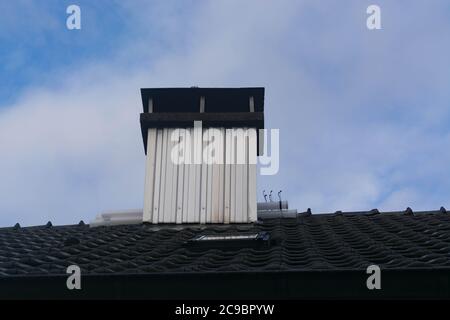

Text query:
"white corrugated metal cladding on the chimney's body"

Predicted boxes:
[[143, 127, 257, 223]]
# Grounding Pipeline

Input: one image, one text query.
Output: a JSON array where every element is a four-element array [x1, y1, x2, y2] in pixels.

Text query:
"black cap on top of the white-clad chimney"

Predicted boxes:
[[140, 87, 264, 155]]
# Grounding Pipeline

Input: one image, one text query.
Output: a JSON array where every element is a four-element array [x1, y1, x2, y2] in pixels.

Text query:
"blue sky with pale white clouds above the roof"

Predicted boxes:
[[0, 0, 450, 226]]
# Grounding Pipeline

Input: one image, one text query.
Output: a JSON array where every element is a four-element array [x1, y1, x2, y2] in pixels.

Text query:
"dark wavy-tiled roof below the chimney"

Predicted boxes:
[[0, 208, 450, 294]]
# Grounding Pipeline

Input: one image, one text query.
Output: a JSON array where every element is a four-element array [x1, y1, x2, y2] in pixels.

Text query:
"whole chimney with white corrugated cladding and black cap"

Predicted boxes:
[[140, 87, 264, 224]]
